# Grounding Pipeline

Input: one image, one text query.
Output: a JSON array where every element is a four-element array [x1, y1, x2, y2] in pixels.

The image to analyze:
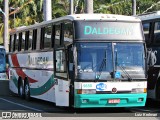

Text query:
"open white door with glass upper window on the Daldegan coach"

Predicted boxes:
[[55, 49, 69, 106]]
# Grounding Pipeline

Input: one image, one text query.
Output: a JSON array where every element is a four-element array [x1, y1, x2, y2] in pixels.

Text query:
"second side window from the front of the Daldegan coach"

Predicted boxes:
[[55, 25, 61, 46]]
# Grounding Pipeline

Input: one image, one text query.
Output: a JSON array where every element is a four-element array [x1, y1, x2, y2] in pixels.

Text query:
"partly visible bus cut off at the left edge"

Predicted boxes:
[[0, 45, 7, 80]]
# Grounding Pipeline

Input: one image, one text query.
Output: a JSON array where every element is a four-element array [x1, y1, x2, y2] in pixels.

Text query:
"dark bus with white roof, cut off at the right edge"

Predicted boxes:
[[138, 11, 160, 100]]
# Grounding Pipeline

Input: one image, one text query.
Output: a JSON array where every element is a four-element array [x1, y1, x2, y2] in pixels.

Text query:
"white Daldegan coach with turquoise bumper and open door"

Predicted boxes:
[[8, 14, 147, 108]]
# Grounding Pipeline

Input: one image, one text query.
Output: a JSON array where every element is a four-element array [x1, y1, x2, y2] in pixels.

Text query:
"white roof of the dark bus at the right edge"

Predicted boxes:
[[137, 11, 160, 20]]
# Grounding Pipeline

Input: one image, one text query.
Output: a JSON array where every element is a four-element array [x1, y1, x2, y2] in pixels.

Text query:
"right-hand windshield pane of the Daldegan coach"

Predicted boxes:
[[114, 43, 145, 79]]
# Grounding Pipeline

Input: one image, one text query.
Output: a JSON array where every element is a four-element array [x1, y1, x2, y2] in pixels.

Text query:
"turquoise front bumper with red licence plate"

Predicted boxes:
[[74, 93, 147, 108]]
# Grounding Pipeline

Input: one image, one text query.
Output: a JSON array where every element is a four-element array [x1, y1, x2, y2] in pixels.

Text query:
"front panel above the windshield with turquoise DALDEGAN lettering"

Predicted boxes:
[[75, 21, 143, 40]]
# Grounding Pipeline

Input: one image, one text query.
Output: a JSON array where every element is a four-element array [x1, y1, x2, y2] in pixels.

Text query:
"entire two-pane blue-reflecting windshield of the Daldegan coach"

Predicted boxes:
[[77, 43, 145, 80]]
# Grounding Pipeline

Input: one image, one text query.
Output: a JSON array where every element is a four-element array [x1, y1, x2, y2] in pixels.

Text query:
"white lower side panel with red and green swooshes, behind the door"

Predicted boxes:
[[10, 52, 55, 102]]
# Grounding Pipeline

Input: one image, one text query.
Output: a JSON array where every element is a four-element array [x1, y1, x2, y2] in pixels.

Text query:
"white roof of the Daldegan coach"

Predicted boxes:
[[10, 14, 141, 33]]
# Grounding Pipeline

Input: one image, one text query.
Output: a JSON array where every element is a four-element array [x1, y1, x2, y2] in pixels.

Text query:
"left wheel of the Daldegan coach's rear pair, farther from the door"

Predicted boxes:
[[18, 79, 24, 99]]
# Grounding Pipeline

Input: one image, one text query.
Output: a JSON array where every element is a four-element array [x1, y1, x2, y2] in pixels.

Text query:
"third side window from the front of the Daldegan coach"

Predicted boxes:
[[44, 25, 52, 48]]
